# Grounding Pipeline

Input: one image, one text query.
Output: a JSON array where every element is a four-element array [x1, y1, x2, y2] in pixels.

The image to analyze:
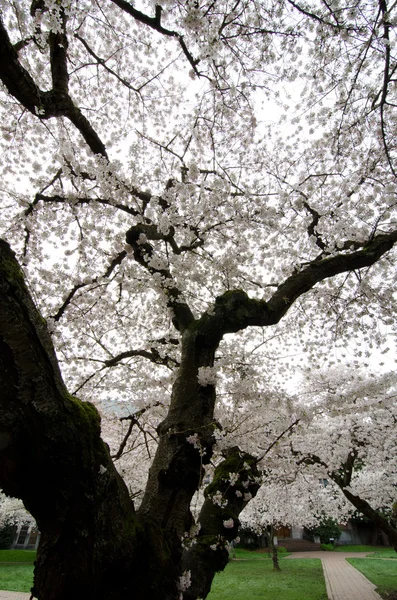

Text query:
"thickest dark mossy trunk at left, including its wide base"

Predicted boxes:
[[0, 242, 180, 600]]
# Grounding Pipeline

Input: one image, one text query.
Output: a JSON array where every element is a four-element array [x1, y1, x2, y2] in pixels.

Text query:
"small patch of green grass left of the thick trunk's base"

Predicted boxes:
[[0, 550, 36, 592]]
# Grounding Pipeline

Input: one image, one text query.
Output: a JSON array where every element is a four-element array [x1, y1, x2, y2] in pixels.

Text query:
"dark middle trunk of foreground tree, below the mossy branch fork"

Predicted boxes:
[[139, 322, 215, 540]]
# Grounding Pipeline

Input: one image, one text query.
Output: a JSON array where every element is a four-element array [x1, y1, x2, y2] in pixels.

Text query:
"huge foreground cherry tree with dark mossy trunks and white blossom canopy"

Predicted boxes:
[[0, 0, 397, 600]]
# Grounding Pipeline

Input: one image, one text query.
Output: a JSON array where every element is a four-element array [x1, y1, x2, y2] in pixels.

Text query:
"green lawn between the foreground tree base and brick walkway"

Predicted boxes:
[[208, 549, 327, 600]]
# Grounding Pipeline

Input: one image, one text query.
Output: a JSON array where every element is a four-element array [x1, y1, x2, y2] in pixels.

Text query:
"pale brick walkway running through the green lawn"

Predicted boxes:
[[286, 551, 382, 600]]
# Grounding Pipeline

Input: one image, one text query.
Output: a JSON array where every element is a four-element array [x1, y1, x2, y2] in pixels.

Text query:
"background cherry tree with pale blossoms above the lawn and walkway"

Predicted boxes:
[[240, 368, 397, 547]]
